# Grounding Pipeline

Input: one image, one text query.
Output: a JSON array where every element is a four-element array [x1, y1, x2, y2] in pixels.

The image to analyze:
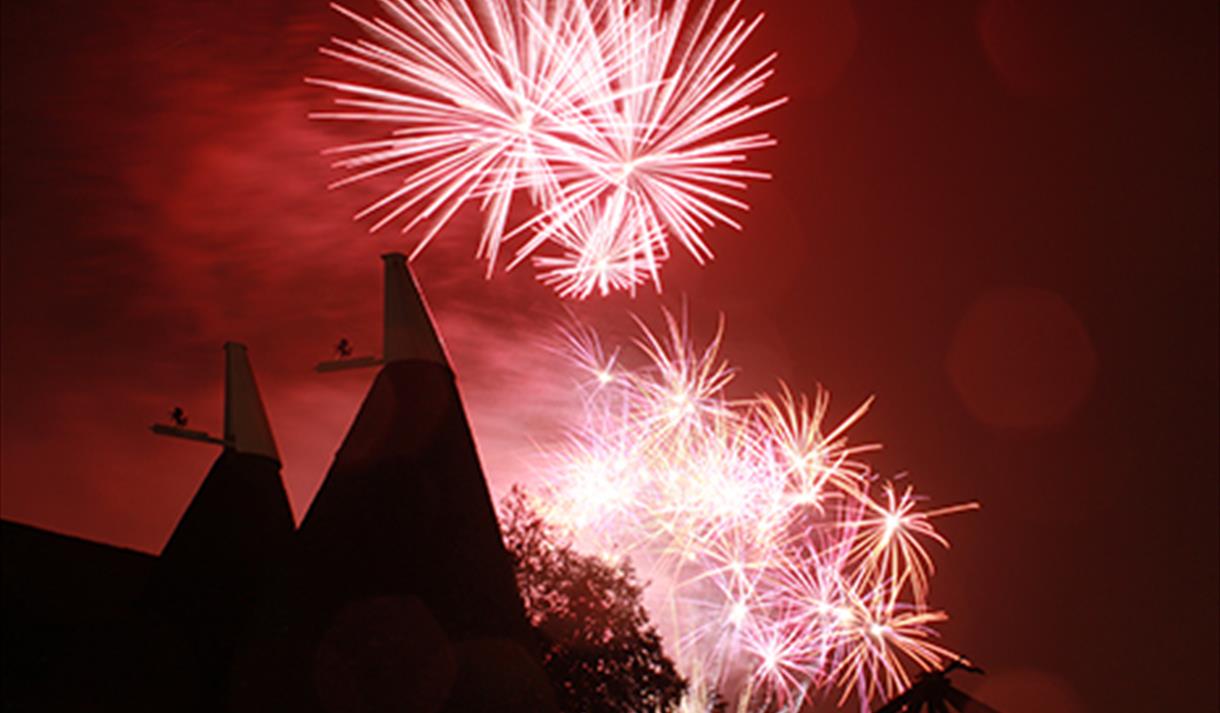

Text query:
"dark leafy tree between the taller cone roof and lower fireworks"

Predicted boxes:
[[501, 487, 687, 713]]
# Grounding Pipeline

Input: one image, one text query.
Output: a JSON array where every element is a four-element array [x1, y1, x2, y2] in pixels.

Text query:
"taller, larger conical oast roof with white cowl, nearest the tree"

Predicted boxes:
[[245, 254, 548, 713]]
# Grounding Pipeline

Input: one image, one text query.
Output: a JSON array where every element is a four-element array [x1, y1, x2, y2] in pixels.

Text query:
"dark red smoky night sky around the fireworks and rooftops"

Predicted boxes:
[[0, 0, 1220, 713]]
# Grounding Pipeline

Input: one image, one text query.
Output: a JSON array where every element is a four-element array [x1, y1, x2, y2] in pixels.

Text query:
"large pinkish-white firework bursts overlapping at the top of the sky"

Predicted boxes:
[[306, 0, 784, 299]]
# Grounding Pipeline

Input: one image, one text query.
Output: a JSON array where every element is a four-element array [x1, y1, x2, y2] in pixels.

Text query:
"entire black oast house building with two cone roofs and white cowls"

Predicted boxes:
[[0, 254, 553, 713]]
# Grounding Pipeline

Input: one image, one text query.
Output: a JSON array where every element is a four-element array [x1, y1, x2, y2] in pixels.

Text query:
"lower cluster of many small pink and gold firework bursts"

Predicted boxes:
[[537, 314, 977, 711]]
